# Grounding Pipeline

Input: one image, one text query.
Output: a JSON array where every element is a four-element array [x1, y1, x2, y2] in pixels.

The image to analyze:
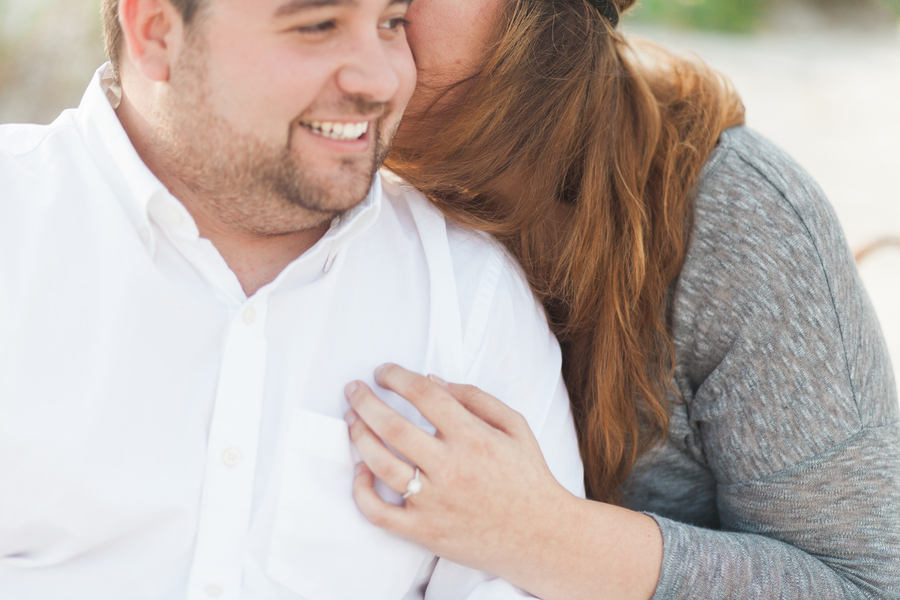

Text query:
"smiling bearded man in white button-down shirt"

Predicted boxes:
[[0, 0, 581, 600]]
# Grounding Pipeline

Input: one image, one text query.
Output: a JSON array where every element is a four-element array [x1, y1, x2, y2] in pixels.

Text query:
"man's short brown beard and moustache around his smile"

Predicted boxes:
[[159, 34, 395, 236]]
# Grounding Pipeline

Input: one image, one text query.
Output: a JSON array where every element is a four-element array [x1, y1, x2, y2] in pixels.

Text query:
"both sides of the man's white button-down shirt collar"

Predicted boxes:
[[67, 63, 383, 272]]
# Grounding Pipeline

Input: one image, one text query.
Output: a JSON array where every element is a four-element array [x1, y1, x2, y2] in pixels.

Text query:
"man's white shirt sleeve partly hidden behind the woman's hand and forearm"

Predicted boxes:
[[425, 237, 584, 600]]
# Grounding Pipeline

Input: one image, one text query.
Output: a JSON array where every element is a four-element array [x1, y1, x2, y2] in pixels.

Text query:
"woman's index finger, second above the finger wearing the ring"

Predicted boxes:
[[375, 363, 486, 433]]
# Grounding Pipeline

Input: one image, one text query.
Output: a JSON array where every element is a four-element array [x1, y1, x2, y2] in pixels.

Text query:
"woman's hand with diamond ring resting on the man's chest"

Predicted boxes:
[[346, 365, 578, 585]]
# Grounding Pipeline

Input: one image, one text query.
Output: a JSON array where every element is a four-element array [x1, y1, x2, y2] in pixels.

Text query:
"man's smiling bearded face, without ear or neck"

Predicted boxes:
[[162, 0, 415, 235]]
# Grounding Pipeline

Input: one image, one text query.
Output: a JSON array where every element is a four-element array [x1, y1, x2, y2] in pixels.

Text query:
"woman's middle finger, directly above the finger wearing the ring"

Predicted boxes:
[[344, 381, 440, 474]]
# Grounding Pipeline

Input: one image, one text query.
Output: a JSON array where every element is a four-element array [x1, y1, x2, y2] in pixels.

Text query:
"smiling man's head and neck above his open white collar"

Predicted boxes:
[[106, 0, 415, 295]]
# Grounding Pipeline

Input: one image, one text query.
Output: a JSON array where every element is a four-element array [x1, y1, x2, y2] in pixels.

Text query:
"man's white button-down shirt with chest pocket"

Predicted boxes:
[[0, 68, 582, 600]]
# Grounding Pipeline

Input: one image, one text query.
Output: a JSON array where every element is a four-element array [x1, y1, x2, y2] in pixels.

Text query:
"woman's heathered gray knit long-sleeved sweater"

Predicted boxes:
[[622, 128, 900, 600]]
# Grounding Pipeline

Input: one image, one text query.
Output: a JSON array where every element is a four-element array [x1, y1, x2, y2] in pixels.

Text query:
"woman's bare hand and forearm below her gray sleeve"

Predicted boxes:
[[347, 365, 662, 600]]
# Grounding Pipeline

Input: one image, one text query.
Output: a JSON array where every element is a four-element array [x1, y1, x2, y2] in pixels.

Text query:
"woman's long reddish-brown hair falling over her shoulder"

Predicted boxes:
[[387, 0, 743, 502]]
